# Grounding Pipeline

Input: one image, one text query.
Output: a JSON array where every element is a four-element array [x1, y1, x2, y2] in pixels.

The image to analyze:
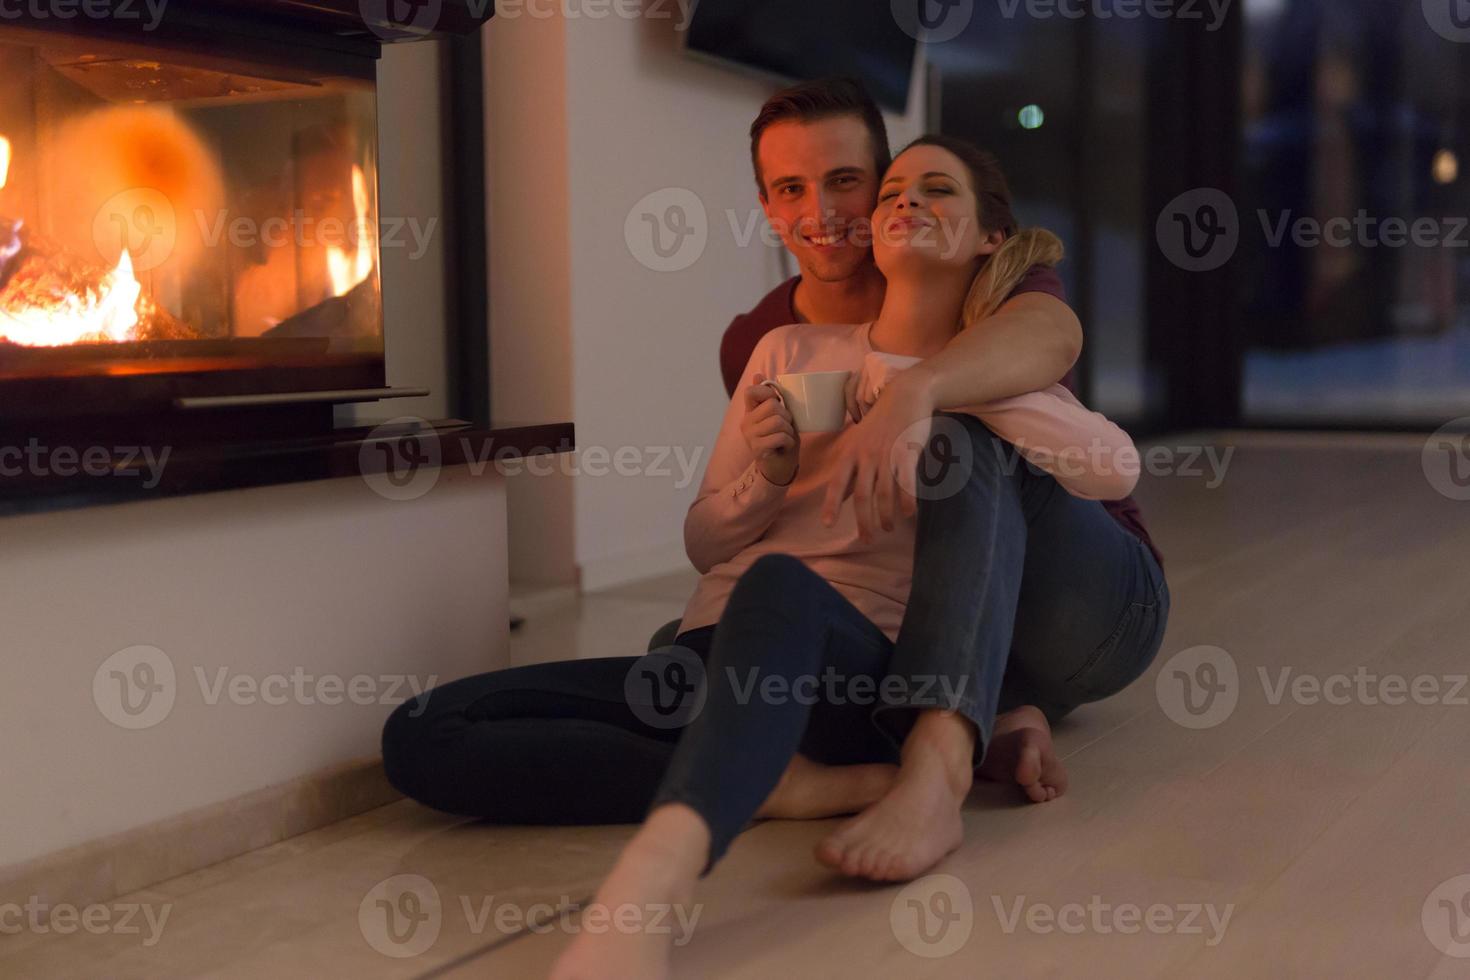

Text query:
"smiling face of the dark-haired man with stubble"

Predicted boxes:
[[760, 116, 879, 282]]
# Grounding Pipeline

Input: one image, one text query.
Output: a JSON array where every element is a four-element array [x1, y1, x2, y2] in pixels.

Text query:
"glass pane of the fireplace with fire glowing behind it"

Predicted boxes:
[[0, 26, 382, 394]]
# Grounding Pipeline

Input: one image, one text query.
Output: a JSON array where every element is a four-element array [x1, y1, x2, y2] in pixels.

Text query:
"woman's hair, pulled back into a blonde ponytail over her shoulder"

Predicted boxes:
[[895, 134, 1064, 329]]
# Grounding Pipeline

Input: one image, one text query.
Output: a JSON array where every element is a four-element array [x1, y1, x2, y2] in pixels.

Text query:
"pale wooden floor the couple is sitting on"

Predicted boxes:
[[11, 433, 1470, 979]]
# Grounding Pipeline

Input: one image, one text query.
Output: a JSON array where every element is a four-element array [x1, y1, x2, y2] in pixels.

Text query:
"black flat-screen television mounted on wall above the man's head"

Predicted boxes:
[[685, 0, 919, 112]]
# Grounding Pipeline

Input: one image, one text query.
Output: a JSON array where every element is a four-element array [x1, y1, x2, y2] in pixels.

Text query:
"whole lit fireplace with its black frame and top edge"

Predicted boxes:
[[0, 0, 490, 433]]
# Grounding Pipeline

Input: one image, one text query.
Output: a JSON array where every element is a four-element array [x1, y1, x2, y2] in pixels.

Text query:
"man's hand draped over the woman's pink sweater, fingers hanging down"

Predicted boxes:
[[822, 367, 935, 544]]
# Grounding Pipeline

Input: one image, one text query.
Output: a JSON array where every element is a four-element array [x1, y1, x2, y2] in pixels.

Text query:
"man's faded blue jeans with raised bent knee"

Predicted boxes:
[[889, 414, 1170, 752]]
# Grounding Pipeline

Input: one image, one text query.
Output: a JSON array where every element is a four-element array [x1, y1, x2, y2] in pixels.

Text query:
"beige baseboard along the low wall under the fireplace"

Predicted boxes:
[[0, 757, 401, 907]]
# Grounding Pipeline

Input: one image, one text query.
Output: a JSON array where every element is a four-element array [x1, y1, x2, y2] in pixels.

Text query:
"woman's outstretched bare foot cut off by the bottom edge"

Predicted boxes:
[[551, 804, 710, 980]]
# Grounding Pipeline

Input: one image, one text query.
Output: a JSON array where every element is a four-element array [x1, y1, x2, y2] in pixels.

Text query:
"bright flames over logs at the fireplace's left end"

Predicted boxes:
[[0, 248, 143, 347]]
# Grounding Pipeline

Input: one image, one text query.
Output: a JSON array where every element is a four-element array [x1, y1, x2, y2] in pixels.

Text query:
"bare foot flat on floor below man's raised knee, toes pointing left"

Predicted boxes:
[[816, 725, 973, 882]]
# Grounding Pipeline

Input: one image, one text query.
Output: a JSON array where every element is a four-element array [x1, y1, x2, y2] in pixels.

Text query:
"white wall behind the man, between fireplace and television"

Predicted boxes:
[[487, 11, 923, 588]]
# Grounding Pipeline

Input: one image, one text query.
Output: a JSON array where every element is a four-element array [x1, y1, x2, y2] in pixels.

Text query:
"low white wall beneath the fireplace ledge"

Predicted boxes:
[[0, 467, 509, 867]]
